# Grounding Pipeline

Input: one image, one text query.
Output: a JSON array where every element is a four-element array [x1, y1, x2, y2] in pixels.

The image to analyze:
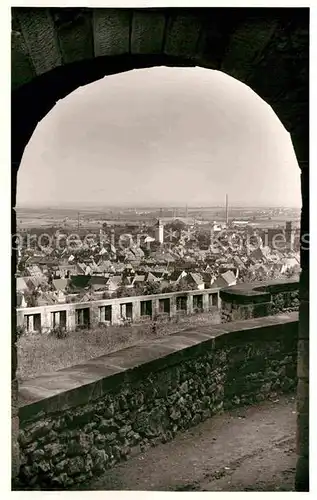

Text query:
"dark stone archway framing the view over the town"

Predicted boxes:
[[11, 8, 309, 491]]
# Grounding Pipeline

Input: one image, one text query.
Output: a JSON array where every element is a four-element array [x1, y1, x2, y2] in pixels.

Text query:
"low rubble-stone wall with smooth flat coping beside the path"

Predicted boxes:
[[19, 313, 298, 489]]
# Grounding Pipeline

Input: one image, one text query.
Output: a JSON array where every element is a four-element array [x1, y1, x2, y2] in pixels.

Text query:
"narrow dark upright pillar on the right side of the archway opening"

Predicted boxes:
[[295, 163, 309, 492]]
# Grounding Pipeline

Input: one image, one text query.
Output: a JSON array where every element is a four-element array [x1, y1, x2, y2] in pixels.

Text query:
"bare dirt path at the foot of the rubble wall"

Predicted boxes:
[[85, 396, 296, 491]]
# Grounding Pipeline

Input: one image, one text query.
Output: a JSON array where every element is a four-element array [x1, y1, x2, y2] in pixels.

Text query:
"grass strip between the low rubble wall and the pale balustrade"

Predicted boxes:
[[17, 313, 220, 380]]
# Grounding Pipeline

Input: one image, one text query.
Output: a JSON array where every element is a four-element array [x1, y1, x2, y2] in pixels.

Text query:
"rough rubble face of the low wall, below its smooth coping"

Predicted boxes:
[[19, 321, 298, 489]]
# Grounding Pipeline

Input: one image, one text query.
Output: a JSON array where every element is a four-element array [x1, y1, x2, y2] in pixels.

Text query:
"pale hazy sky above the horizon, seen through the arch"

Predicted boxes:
[[18, 67, 301, 207]]
